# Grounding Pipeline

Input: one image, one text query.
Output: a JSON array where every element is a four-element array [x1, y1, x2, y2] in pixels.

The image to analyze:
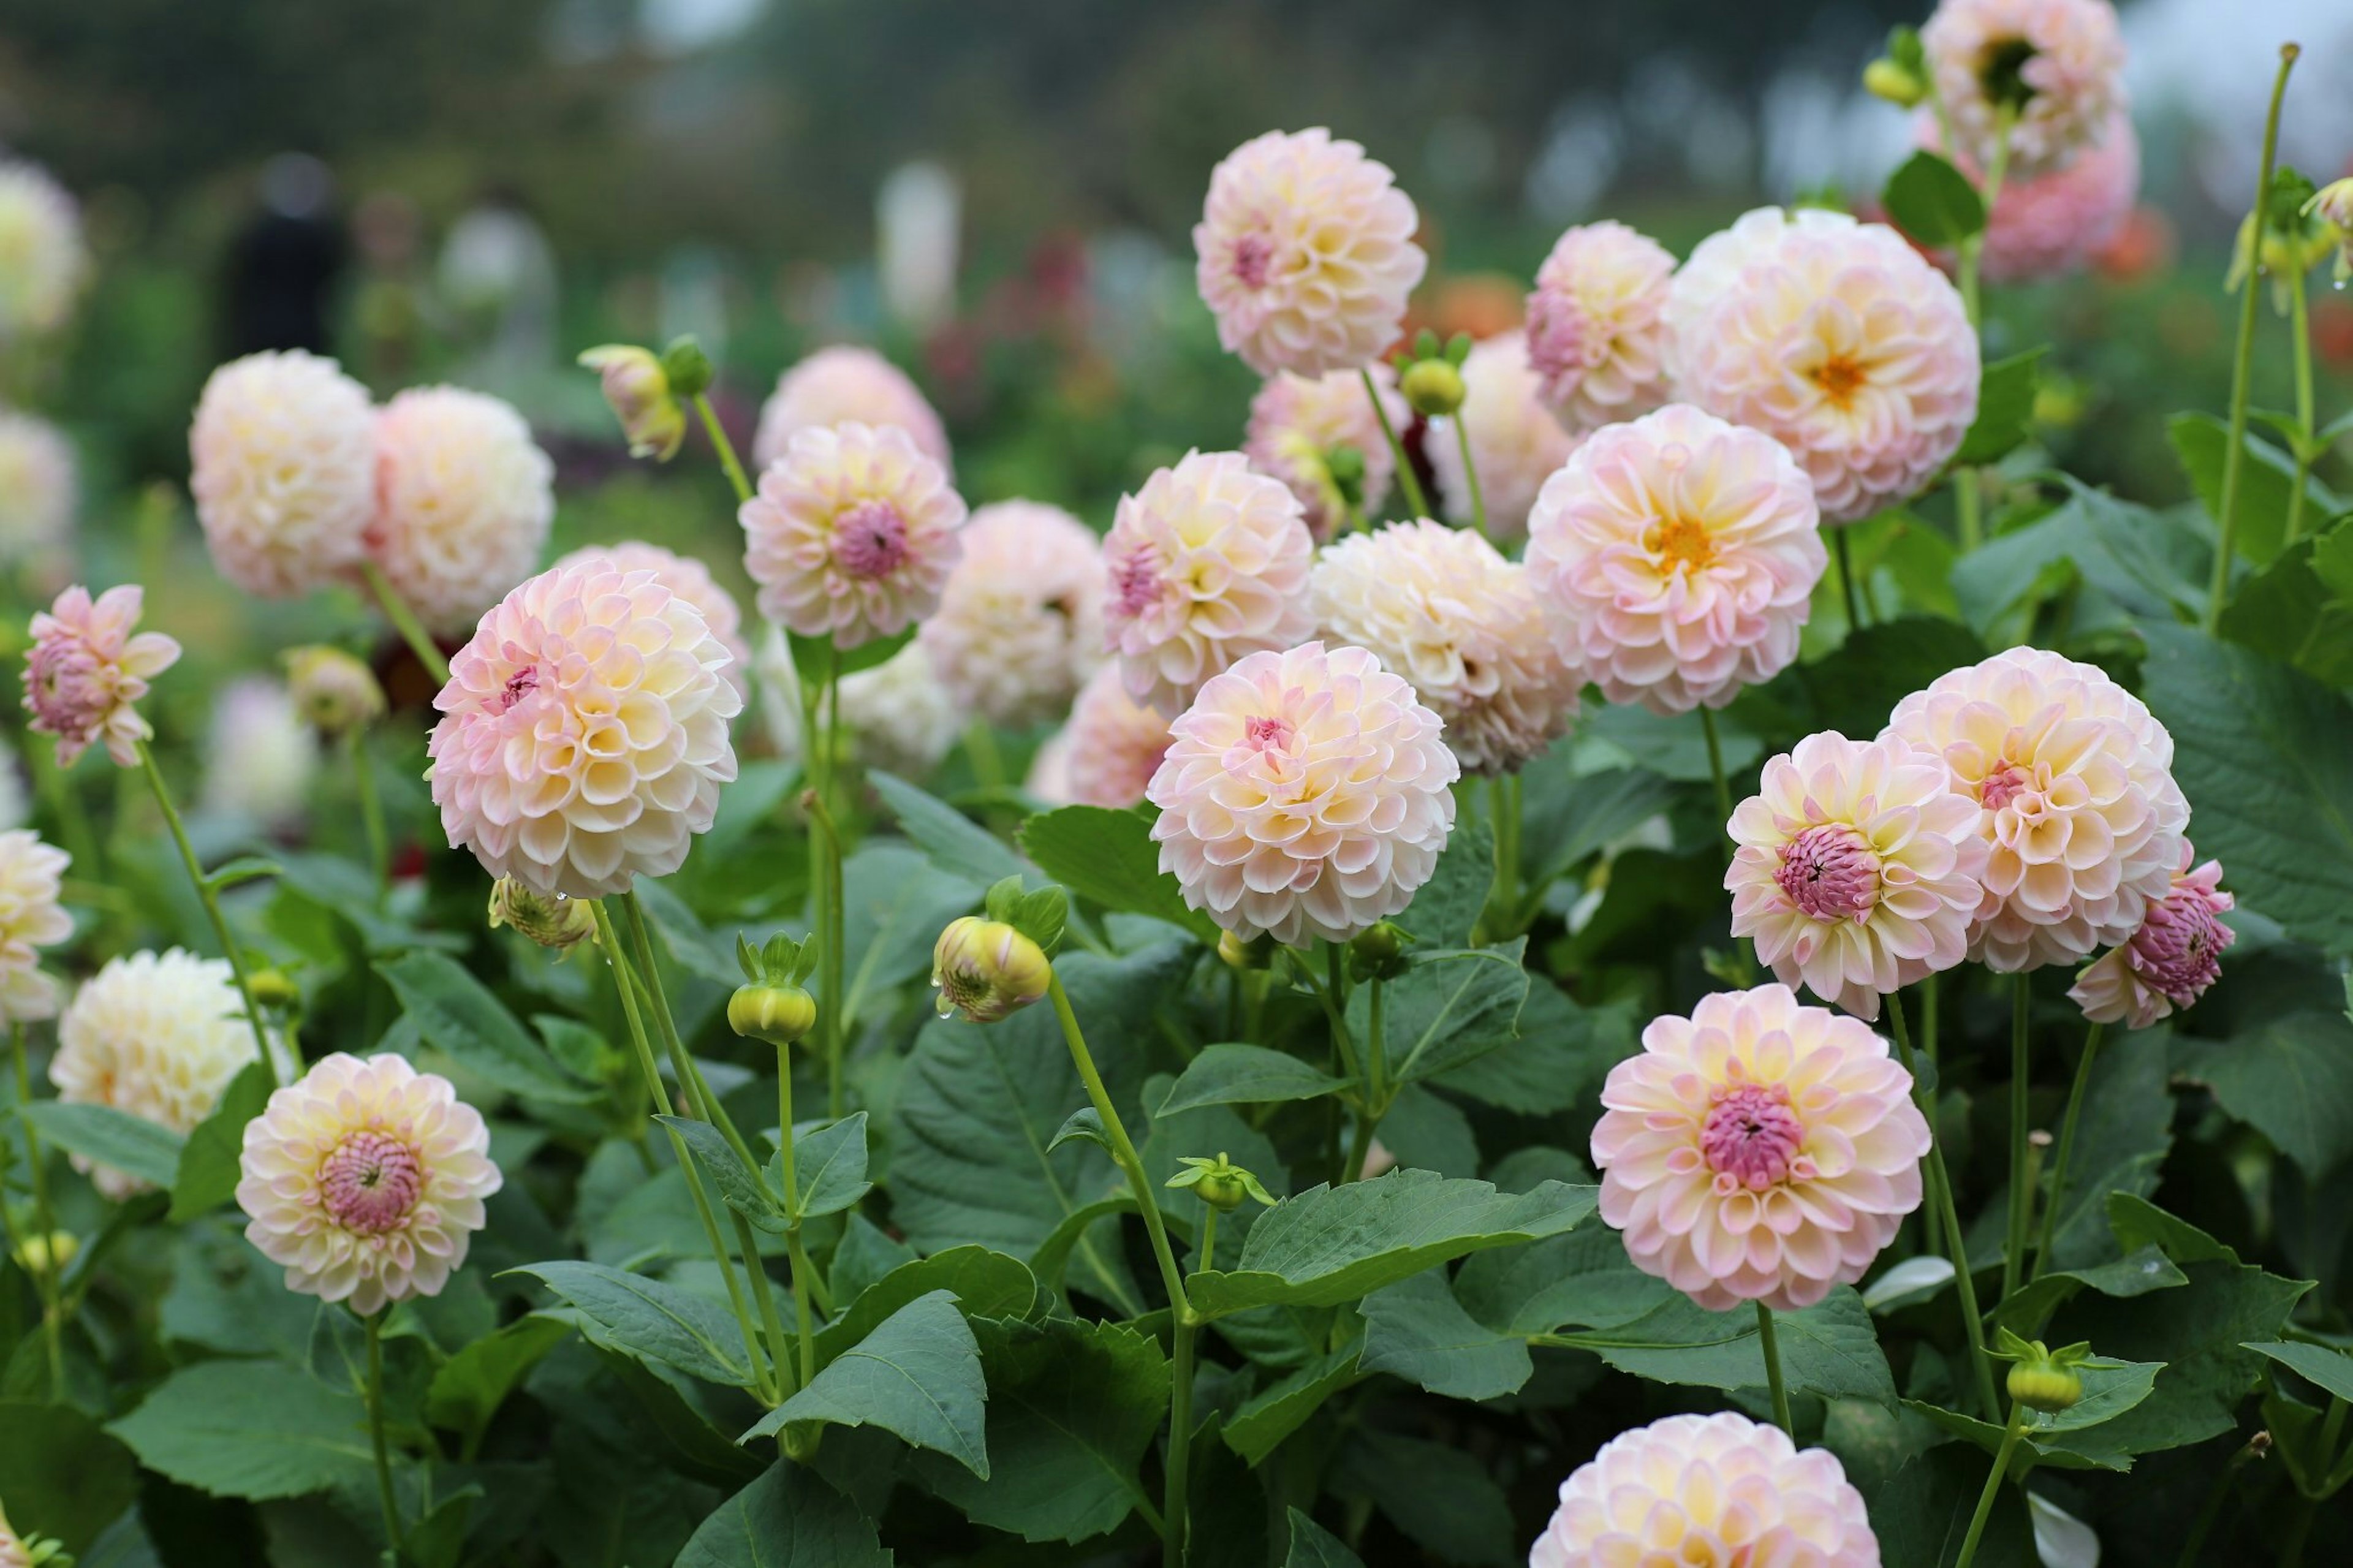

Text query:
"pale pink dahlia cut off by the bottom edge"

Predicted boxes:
[[1527, 1411, 1880, 1568]]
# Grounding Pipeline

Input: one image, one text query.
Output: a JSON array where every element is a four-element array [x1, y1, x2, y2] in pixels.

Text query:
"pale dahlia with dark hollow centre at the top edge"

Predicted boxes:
[[1920, 0, 2125, 179]]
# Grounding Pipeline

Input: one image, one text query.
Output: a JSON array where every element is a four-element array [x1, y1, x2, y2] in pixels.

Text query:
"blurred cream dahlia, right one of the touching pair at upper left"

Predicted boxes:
[[367, 386, 555, 635]]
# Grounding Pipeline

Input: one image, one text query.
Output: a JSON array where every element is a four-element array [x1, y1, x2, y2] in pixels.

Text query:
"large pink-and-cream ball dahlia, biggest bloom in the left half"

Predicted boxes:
[[426, 556, 743, 900]]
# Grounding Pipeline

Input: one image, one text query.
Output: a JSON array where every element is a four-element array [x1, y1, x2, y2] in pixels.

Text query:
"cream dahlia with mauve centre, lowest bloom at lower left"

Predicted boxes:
[[238, 1050, 501, 1314]]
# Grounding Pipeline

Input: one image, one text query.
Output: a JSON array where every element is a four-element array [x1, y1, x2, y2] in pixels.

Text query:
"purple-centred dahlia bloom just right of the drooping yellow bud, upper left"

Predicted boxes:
[[737, 422, 964, 650]]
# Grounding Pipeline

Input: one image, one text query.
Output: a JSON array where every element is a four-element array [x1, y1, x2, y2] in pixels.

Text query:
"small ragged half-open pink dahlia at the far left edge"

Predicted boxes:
[[23, 584, 179, 768]]
